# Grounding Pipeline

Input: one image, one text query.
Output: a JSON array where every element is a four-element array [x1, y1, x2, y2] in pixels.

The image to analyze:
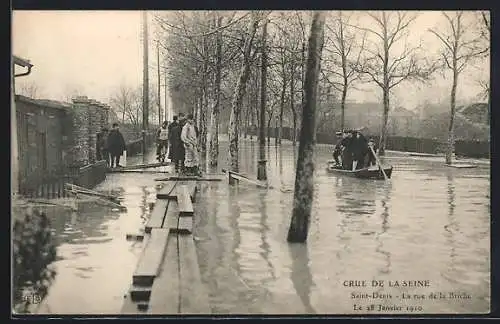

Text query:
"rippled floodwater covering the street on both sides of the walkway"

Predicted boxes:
[[34, 136, 490, 314]]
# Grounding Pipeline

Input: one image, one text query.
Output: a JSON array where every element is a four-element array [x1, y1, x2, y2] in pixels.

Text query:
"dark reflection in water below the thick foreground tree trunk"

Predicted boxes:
[[288, 243, 316, 314]]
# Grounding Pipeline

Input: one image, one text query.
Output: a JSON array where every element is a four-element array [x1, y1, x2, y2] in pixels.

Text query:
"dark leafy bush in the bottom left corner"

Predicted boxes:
[[12, 210, 56, 313]]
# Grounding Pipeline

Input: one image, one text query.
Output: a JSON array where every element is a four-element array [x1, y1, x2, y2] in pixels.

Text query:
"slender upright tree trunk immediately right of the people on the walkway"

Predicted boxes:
[[209, 16, 223, 167]]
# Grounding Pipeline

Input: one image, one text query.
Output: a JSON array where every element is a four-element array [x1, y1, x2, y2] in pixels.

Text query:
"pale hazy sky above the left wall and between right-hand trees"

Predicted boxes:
[[12, 11, 489, 109]]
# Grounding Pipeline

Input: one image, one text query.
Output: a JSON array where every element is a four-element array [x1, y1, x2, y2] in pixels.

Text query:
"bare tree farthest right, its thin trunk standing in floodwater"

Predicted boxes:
[[429, 11, 489, 165]]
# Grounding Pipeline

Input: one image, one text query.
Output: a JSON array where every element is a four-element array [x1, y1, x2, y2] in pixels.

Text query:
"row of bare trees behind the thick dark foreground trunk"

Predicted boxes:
[[155, 11, 489, 170]]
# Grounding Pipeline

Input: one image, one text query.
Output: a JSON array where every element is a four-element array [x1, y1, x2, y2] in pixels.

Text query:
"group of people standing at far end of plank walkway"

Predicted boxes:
[[156, 113, 200, 175]]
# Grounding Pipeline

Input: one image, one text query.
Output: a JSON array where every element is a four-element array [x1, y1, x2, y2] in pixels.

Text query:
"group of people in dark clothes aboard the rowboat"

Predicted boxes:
[[333, 130, 377, 171]]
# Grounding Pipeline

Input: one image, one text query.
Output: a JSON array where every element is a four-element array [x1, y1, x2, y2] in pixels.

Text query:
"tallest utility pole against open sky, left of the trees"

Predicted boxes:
[[142, 10, 149, 157]]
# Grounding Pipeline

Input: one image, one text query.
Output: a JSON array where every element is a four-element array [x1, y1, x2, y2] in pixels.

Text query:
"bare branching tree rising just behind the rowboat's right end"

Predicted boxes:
[[356, 11, 434, 155]]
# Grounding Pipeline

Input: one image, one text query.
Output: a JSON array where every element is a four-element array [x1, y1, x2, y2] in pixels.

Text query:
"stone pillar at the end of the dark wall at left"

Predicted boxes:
[[71, 96, 90, 166]]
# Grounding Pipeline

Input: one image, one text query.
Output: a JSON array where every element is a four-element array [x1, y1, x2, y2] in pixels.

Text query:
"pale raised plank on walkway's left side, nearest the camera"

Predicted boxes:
[[132, 228, 169, 286]]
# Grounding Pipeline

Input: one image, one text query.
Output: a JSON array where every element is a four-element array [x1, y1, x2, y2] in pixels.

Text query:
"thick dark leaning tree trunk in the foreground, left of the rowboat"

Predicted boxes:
[[287, 11, 325, 242]]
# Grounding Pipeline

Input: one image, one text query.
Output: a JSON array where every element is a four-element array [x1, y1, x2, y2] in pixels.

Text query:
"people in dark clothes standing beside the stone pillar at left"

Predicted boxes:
[[96, 123, 127, 168]]
